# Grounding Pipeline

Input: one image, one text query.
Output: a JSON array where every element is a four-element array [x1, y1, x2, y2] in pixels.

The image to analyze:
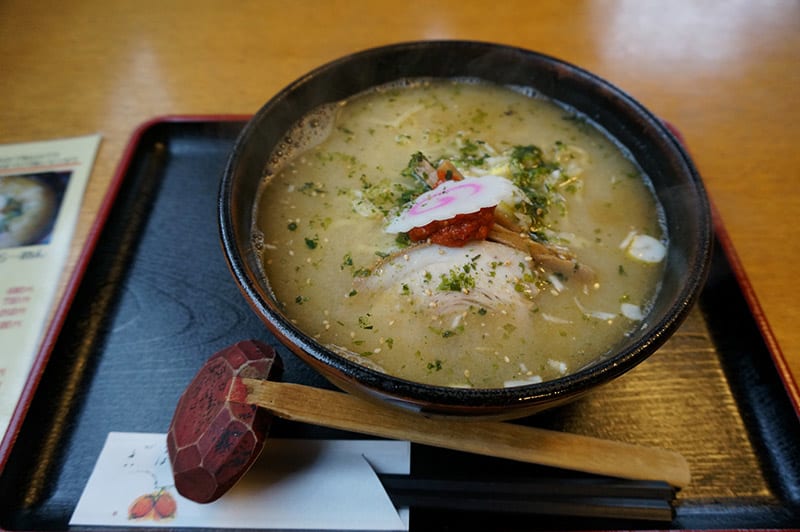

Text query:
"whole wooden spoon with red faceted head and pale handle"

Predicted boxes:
[[167, 341, 690, 503]]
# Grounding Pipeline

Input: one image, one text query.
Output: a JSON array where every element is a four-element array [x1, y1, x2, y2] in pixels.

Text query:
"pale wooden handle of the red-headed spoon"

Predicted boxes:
[[242, 379, 691, 487]]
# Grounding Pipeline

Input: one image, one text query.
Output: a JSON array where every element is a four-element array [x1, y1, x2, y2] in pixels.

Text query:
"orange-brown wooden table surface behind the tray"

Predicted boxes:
[[0, 0, 800, 390]]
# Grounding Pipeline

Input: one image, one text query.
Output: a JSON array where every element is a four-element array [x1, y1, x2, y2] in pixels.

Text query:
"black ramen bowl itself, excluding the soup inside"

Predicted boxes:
[[219, 41, 712, 418]]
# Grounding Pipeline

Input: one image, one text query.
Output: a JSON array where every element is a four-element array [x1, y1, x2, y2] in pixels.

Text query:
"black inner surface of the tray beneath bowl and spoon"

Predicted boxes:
[[0, 116, 800, 530]]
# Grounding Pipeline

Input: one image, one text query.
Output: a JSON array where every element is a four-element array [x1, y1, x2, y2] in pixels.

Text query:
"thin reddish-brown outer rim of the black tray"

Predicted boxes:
[[0, 113, 800, 528]]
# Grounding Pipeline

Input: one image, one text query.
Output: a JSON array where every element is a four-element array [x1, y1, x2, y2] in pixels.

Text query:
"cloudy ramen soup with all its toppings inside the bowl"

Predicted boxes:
[[254, 80, 667, 388]]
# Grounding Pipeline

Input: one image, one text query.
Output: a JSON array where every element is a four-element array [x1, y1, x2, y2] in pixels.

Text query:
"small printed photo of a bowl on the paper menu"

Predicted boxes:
[[0, 171, 72, 249]]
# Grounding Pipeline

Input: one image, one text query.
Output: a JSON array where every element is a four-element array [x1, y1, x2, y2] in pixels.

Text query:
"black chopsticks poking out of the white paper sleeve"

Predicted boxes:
[[379, 475, 675, 522]]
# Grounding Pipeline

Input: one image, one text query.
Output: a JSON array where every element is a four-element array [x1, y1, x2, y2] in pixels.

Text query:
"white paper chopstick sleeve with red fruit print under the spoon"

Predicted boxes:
[[70, 433, 410, 530]]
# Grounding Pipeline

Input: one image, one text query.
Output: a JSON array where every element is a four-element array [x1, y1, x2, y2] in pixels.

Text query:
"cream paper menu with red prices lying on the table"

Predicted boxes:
[[0, 135, 100, 436]]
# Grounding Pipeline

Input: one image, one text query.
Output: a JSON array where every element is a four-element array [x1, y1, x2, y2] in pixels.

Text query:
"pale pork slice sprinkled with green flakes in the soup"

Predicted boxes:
[[356, 241, 539, 326]]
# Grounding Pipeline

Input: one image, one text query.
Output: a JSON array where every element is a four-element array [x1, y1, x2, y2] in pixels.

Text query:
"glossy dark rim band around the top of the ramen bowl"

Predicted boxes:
[[217, 40, 713, 410]]
